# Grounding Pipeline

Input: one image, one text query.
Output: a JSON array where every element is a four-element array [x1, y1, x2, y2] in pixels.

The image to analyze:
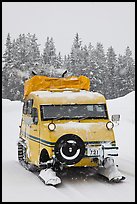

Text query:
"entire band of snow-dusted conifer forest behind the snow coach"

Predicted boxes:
[[2, 33, 135, 101]]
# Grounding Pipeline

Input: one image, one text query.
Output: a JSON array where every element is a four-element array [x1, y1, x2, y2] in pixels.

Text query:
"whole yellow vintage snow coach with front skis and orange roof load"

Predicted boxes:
[[18, 75, 125, 185]]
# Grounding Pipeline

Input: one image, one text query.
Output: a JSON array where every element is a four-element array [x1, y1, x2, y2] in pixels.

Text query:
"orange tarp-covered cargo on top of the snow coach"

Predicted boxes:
[[24, 75, 90, 98]]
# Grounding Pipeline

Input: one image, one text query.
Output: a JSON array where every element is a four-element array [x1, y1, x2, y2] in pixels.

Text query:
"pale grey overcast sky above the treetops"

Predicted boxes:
[[2, 2, 135, 57]]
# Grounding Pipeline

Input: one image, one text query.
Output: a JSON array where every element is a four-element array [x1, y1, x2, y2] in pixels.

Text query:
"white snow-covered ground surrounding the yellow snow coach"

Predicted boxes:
[[2, 92, 135, 202]]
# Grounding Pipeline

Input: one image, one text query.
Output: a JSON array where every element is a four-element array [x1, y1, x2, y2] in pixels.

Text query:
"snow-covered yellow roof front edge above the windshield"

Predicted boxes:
[[27, 90, 106, 105]]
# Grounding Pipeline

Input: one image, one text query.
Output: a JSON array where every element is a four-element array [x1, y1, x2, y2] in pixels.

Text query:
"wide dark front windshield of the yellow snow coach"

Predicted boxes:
[[40, 104, 108, 120]]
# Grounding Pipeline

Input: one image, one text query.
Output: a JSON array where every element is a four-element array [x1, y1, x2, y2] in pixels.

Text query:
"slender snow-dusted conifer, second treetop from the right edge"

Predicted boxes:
[[105, 46, 118, 99]]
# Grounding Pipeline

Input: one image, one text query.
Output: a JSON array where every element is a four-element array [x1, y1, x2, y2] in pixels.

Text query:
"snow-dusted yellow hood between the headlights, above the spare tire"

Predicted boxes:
[[44, 120, 115, 142]]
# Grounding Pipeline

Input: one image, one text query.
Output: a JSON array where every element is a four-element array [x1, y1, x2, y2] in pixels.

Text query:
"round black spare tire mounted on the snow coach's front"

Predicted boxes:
[[54, 134, 85, 165]]
